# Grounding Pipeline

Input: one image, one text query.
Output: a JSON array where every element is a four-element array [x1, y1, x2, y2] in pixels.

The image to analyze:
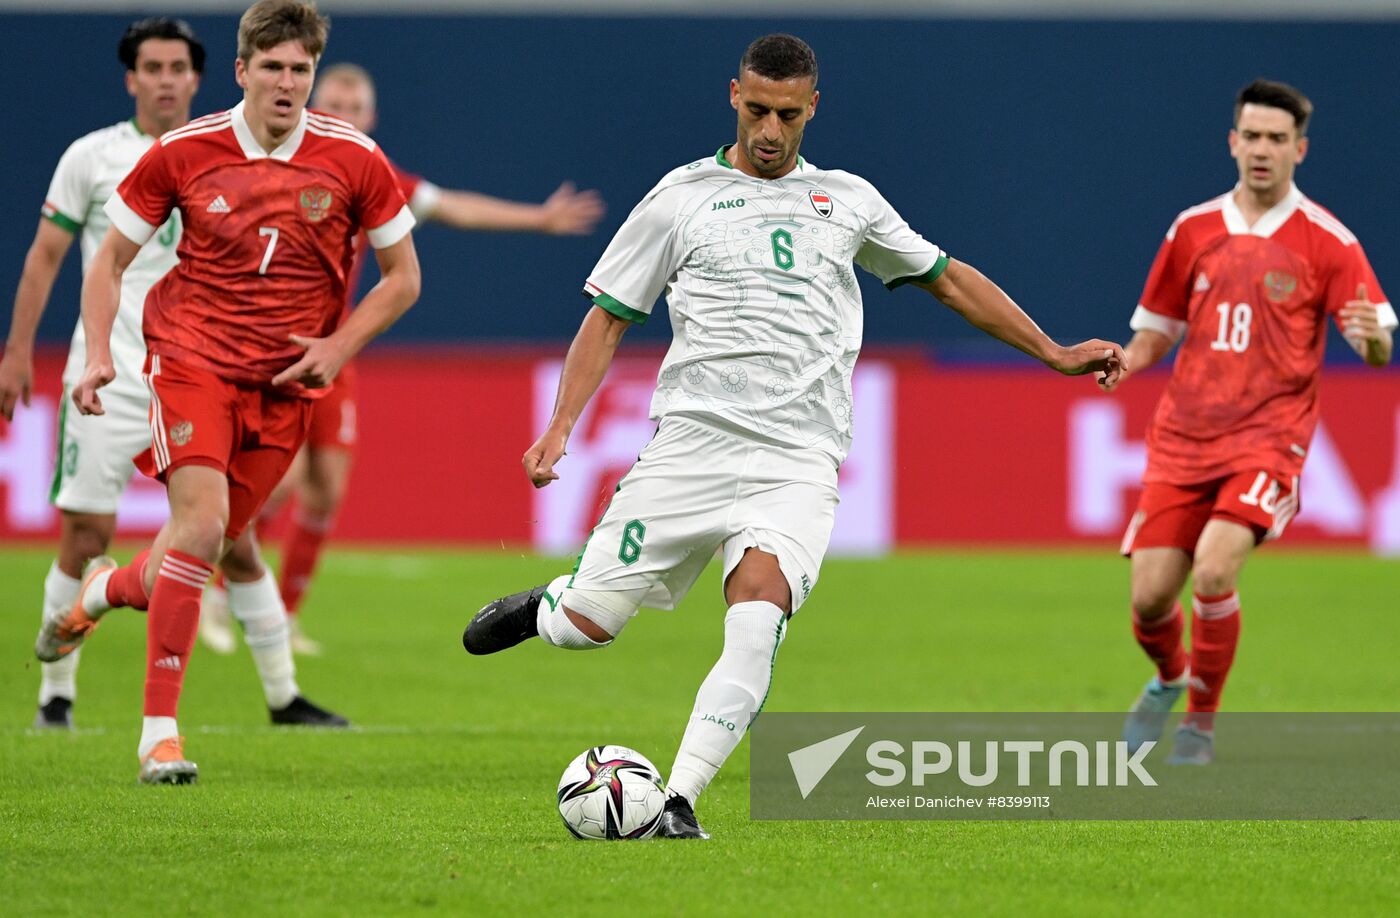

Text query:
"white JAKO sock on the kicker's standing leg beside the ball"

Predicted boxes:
[[666, 602, 787, 805]]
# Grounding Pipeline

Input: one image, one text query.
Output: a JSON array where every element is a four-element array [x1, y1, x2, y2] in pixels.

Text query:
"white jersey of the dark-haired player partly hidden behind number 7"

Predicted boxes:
[[43, 119, 181, 400]]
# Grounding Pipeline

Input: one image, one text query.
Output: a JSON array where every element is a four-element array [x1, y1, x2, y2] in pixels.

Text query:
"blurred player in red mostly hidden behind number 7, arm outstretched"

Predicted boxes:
[[200, 63, 606, 655]]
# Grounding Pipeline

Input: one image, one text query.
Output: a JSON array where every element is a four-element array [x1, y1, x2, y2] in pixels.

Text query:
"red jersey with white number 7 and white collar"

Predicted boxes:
[[106, 104, 413, 395]]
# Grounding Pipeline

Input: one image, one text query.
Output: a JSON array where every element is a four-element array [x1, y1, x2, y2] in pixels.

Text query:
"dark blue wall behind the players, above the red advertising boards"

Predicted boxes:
[[0, 15, 1400, 358]]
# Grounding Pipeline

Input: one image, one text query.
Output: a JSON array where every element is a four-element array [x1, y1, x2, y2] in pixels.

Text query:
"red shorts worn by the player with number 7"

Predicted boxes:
[[136, 354, 311, 539]]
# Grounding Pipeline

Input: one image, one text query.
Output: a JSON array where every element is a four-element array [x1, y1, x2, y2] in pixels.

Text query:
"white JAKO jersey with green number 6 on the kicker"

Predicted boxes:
[[584, 148, 948, 465]]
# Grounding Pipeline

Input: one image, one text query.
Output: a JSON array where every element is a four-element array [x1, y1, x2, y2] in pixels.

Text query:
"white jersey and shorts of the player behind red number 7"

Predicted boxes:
[[43, 119, 181, 514]]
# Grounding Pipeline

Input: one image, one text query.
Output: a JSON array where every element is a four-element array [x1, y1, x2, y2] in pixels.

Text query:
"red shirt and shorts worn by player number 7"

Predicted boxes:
[[106, 104, 413, 539]]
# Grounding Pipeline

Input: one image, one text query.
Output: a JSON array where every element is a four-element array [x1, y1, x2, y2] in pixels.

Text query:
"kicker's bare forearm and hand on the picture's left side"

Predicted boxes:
[[521, 306, 631, 487]]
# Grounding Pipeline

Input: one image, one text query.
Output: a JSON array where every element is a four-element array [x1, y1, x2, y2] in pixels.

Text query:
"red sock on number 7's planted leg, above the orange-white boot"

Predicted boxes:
[[146, 551, 214, 716]]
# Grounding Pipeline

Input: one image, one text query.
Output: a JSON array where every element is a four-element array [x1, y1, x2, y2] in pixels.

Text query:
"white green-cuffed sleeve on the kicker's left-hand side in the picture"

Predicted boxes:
[[584, 186, 680, 325]]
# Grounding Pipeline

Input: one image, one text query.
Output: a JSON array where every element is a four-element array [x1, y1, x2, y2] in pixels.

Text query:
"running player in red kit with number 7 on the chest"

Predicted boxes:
[[38, 0, 419, 784]]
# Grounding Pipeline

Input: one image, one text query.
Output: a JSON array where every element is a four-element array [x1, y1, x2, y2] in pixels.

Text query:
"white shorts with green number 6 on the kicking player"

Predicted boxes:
[[570, 416, 840, 613]]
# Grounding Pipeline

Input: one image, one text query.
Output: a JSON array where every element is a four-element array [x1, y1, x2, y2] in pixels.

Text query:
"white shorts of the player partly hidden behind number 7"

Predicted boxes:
[[49, 374, 151, 514]]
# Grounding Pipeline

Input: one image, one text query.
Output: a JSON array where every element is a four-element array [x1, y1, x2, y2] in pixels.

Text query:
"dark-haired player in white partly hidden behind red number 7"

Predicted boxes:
[[0, 17, 344, 728]]
